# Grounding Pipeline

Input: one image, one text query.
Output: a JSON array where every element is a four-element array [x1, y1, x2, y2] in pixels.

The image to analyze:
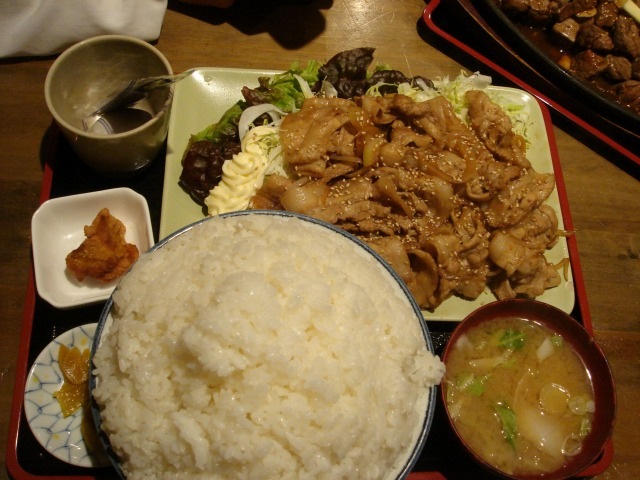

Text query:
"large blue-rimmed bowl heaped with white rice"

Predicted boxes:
[[90, 211, 444, 480]]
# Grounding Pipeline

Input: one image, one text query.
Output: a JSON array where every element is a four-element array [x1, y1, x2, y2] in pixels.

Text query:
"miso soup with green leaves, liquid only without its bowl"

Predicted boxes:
[[443, 318, 595, 475]]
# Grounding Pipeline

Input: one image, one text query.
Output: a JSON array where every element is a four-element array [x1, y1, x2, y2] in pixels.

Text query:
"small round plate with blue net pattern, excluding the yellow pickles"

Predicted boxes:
[[24, 323, 109, 467]]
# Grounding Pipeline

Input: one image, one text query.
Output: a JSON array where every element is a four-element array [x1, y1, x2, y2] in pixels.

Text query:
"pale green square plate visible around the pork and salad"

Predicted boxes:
[[160, 68, 575, 321]]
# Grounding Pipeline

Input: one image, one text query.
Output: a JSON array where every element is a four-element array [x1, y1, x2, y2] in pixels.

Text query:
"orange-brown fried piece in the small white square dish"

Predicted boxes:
[[66, 208, 139, 283]]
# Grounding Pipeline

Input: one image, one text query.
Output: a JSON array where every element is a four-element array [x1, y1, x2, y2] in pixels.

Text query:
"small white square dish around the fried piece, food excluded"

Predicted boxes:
[[31, 188, 155, 308]]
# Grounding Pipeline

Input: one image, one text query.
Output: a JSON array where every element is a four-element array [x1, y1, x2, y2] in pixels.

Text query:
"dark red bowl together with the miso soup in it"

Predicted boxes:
[[443, 301, 615, 479]]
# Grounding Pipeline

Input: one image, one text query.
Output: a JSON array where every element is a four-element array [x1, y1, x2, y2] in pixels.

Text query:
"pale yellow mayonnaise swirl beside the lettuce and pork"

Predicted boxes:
[[204, 125, 282, 216]]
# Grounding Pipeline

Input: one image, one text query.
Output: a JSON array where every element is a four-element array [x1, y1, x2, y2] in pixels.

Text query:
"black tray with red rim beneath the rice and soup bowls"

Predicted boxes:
[[6, 72, 613, 480]]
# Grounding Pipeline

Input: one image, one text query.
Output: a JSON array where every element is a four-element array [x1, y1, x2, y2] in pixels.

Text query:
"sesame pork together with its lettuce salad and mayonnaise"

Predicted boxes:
[[180, 48, 566, 309]]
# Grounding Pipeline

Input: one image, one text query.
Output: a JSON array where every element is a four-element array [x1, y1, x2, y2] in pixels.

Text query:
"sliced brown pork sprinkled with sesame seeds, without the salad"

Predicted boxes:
[[251, 90, 561, 309]]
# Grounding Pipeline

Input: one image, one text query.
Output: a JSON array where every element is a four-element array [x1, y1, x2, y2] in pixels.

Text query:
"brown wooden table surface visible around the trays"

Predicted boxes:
[[0, 0, 640, 479]]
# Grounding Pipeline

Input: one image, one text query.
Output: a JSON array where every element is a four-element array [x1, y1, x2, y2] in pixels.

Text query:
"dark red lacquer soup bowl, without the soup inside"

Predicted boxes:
[[440, 299, 616, 480]]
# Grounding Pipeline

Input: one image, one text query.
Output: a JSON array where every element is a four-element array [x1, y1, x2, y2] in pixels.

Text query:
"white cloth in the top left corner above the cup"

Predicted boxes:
[[0, 0, 167, 57]]
